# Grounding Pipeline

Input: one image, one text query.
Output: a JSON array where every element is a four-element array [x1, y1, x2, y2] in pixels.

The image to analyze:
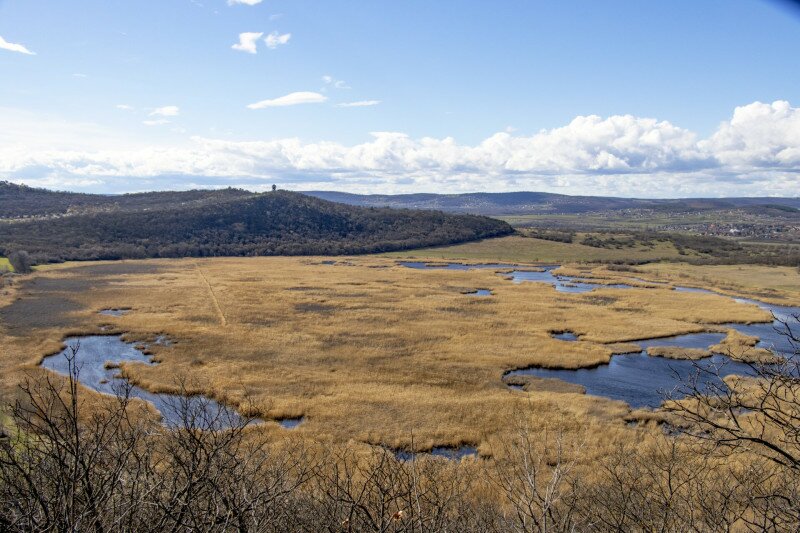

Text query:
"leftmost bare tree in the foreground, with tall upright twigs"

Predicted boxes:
[[0, 347, 148, 532]]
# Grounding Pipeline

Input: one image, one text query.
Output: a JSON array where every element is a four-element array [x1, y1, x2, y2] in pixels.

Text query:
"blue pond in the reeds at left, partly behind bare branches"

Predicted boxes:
[[42, 335, 258, 429]]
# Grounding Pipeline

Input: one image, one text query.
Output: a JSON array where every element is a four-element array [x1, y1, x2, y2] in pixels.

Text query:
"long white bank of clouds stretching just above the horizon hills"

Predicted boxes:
[[0, 99, 800, 197]]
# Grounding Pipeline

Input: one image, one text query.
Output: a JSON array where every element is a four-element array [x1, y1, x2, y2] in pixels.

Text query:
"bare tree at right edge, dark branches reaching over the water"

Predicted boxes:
[[666, 316, 800, 529]]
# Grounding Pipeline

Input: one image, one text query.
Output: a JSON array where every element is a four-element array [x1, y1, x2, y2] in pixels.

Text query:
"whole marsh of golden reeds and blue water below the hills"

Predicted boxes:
[[0, 241, 800, 531]]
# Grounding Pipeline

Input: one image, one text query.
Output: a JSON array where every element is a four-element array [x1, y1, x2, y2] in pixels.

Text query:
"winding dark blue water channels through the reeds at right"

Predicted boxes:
[[400, 262, 800, 408]]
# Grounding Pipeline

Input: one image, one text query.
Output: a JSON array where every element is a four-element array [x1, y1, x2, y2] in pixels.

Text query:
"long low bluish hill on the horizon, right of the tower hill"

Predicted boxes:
[[305, 191, 800, 215]]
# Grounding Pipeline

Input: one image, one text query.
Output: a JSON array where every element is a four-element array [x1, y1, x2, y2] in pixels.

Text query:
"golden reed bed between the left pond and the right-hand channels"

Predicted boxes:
[[0, 257, 769, 453]]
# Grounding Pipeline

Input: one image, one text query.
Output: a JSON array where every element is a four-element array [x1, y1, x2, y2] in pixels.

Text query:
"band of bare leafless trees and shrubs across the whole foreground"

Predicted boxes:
[[0, 322, 800, 533]]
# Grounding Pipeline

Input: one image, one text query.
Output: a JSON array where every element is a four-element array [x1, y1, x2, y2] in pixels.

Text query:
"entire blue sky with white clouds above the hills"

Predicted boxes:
[[0, 0, 800, 198]]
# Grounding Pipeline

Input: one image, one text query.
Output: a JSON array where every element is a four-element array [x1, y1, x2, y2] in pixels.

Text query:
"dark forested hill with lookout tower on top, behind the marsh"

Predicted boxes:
[[0, 190, 512, 262]]
